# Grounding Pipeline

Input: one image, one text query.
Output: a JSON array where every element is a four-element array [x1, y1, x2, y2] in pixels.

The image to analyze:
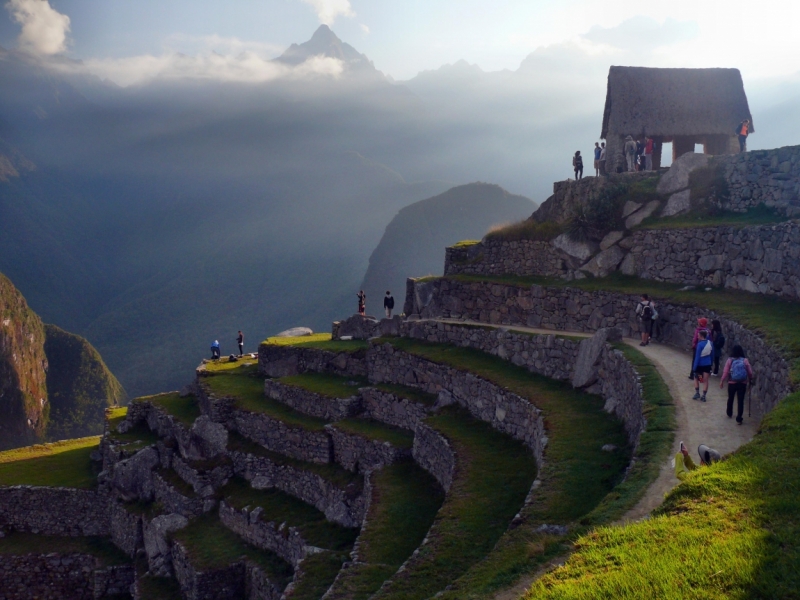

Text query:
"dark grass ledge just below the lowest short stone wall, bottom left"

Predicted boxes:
[[173, 513, 292, 589]]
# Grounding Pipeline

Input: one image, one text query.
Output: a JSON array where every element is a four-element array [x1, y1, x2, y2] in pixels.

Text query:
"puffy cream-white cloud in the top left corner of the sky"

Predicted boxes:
[[6, 0, 69, 55]]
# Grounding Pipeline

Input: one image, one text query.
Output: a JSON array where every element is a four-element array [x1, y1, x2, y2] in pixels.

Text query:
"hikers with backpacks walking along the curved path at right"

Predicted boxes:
[[636, 294, 755, 425]]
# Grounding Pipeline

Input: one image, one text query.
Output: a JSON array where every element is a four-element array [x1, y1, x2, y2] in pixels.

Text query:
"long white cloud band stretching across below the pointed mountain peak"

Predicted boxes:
[[76, 51, 344, 87]]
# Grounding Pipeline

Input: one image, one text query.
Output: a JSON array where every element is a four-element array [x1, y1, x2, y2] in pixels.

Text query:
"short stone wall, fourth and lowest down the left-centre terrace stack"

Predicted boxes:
[[219, 501, 313, 567]]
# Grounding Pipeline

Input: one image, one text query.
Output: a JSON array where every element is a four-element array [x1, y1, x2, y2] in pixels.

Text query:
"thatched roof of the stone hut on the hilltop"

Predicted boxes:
[[600, 67, 755, 139]]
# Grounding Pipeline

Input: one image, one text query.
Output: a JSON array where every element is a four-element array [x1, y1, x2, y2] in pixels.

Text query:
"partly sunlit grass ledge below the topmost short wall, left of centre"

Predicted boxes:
[[203, 365, 326, 431]]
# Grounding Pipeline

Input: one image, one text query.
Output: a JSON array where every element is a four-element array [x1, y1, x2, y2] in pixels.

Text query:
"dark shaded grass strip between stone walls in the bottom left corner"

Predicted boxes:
[[0, 531, 131, 566]]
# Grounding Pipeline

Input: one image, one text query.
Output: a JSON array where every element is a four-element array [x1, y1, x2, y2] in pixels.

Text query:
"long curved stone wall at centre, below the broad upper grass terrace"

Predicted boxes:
[[367, 344, 546, 465]]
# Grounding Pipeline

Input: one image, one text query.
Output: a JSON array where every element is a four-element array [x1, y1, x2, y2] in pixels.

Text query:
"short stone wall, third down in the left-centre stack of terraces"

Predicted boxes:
[[230, 452, 367, 527]]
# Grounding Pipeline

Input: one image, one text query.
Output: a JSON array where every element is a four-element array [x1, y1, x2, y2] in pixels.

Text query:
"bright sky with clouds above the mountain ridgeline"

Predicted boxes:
[[0, 0, 800, 85]]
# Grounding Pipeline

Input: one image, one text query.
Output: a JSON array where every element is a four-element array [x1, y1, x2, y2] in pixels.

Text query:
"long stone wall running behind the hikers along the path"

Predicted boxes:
[[409, 279, 792, 415]]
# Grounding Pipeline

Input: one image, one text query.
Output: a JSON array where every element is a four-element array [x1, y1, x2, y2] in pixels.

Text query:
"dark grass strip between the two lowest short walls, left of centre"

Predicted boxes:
[[221, 477, 358, 552]]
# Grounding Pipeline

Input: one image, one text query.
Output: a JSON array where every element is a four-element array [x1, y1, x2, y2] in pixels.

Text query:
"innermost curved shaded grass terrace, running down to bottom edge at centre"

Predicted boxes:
[[330, 461, 444, 600]]
